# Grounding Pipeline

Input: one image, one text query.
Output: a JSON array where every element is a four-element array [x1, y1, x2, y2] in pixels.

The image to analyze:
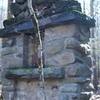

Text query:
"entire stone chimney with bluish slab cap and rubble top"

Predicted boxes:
[[0, 0, 95, 100]]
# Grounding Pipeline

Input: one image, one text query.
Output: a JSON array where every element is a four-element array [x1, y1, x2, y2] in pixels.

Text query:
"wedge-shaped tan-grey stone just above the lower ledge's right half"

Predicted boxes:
[[45, 49, 83, 66]]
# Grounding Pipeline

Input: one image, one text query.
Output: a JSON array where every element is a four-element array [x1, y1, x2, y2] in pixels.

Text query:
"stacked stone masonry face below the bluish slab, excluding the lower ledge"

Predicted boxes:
[[2, 24, 91, 100]]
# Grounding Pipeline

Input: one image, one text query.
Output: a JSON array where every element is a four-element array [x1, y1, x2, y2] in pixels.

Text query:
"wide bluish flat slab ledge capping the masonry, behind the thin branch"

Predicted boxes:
[[0, 11, 95, 38]]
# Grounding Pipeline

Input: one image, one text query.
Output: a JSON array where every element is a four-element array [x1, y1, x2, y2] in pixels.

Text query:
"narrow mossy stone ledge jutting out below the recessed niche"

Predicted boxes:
[[5, 67, 65, 80]]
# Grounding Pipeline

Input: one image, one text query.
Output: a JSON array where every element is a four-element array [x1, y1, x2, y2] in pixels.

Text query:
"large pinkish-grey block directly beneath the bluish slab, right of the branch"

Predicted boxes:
[[44, 24, 79, 43]]
